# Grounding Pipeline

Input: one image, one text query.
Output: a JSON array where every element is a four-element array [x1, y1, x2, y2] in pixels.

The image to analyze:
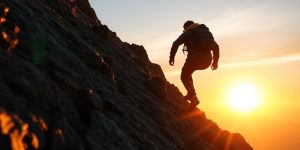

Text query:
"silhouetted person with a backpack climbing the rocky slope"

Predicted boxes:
[[169, 20, 219, 110]]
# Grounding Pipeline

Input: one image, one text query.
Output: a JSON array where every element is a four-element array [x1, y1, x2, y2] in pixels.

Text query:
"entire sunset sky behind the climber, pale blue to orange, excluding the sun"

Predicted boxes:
[[90, 0, 300, 150]]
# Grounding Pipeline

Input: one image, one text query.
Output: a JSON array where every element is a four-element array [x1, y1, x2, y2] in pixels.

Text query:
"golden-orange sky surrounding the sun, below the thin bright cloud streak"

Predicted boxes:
[[168, 62, 300, 150]]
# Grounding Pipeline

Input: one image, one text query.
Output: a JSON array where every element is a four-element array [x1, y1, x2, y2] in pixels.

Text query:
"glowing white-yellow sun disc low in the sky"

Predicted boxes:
[[228, 83, 261, 112]]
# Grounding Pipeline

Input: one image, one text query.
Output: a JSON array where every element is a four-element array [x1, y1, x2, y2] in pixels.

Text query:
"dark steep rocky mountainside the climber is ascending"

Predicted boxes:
[[0, 0, 252, 150]]
